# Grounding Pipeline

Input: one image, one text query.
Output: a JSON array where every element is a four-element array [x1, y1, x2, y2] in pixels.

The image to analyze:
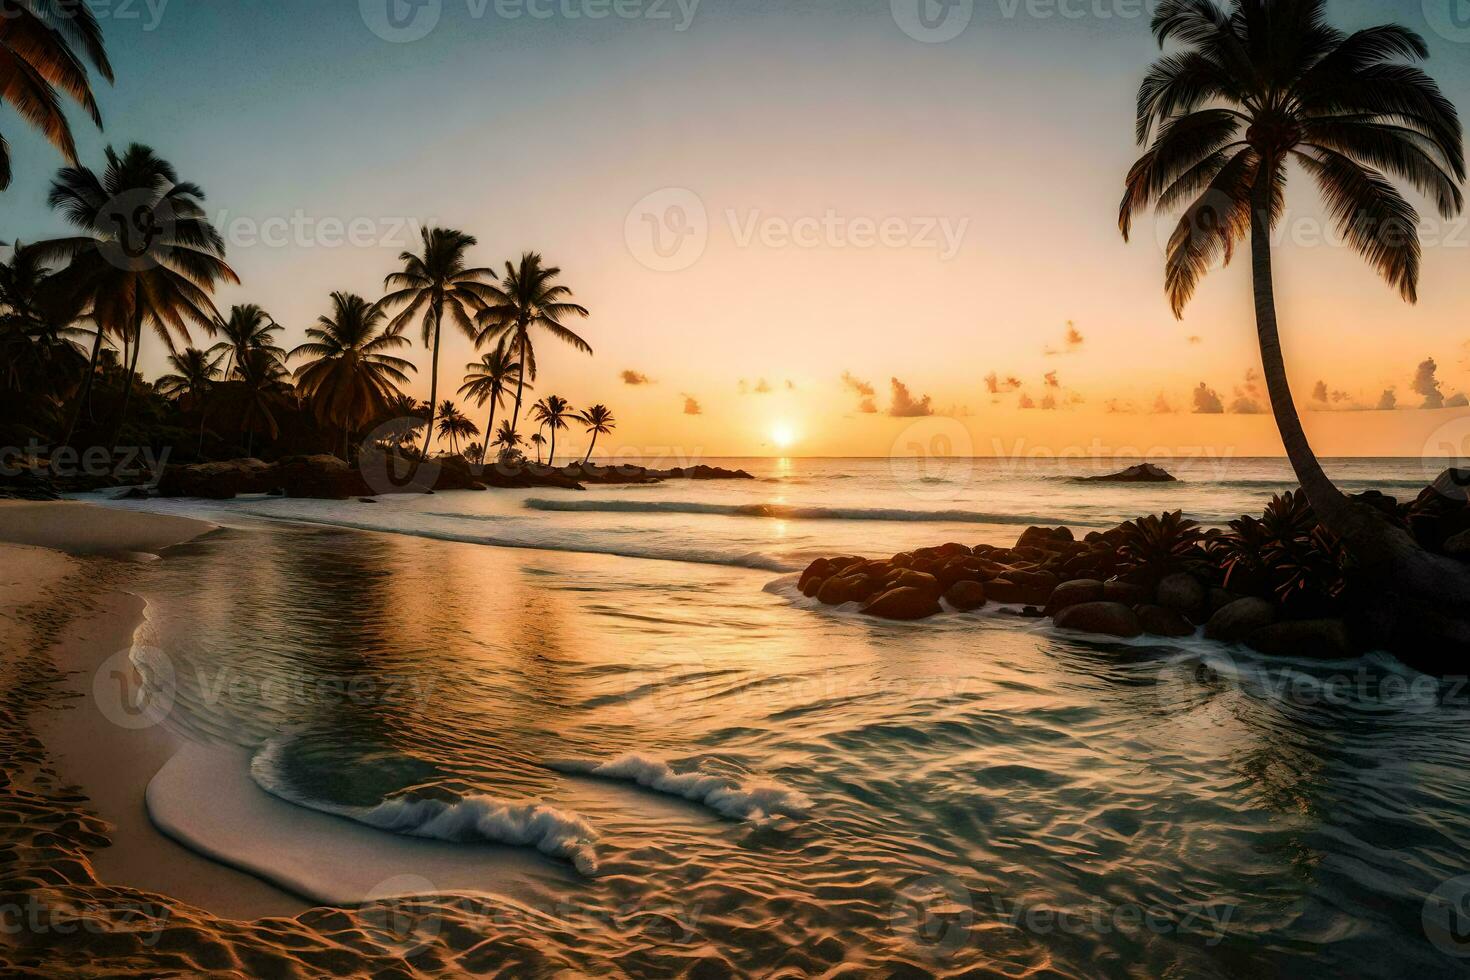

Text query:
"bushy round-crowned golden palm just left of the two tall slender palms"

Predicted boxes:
[[288, 292, 415, 460]]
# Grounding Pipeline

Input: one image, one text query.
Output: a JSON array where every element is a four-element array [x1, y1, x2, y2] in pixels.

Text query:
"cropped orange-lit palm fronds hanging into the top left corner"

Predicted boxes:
[[0, 0, 112, 191]]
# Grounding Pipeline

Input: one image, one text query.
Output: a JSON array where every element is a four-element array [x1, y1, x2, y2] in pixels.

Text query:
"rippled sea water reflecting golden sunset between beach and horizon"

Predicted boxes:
[[85, 460, 1470, 977]]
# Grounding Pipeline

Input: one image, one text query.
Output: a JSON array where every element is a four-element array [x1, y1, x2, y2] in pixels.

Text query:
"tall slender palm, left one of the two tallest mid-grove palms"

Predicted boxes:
[[378, 228, 494, 467]]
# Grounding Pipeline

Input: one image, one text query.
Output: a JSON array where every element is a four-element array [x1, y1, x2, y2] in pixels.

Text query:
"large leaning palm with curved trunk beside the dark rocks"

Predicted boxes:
[[1119, 0, 1470, 644]]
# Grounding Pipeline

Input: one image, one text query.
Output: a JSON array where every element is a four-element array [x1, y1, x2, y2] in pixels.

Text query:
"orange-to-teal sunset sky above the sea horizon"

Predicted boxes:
[[0, 0, 1470, 455]]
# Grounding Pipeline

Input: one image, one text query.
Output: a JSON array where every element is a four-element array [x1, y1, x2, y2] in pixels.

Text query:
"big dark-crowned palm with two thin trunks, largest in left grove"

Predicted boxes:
[[35, 144, 240, 444]]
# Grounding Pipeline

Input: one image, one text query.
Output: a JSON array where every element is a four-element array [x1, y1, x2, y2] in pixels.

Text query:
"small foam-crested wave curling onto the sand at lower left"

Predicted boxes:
[[250, 741, 597, 876]]
